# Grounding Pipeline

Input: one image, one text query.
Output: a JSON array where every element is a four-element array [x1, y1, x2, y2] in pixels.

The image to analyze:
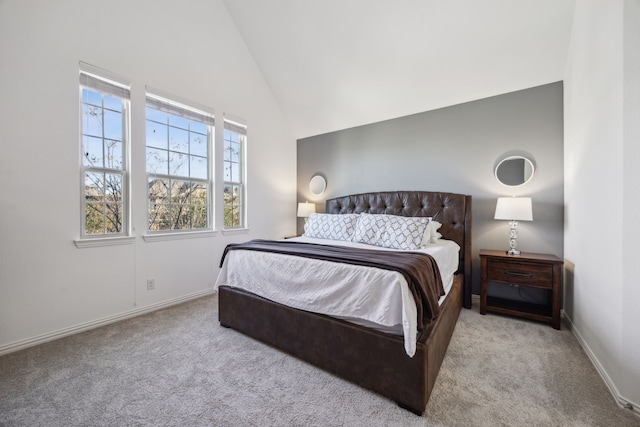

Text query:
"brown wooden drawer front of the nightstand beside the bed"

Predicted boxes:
[[487, 260, 553, 289]]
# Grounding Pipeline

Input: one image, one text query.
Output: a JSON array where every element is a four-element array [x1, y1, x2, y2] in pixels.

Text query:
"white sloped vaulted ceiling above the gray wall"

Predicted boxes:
[[223, 0, 575, 138]]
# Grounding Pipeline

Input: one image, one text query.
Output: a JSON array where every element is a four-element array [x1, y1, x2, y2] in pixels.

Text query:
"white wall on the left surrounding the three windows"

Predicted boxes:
[[0, 0, 296, 353]]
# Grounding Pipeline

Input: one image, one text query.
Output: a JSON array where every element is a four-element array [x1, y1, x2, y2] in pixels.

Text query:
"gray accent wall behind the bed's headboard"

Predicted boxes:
[[297, 82, 564, 293]]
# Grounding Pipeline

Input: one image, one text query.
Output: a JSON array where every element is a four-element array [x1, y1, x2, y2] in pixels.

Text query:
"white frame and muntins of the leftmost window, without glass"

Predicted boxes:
[[76, 66, 131, 241]]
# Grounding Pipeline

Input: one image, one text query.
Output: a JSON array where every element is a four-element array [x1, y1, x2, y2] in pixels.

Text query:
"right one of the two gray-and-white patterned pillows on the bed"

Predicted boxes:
[[351, 213, 429, 250]]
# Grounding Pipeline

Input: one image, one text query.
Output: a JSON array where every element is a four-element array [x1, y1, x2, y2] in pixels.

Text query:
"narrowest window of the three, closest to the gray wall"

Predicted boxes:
[[223, 117, 247, 229]]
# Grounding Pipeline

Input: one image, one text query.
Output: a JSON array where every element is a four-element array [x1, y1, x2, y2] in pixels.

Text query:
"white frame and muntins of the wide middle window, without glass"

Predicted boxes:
[[145, 86, 215, 237]]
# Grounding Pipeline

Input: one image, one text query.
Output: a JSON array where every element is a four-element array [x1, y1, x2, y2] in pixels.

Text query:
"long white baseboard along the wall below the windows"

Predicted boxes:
[[0, 289, 214, 356]]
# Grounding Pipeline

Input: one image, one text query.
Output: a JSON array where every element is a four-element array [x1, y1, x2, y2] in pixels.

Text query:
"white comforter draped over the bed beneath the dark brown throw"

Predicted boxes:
[[214, 237, 460, 357]]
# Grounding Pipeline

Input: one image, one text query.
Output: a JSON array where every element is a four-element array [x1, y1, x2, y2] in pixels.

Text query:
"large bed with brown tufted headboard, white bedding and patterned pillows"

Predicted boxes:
[[215, 191, 471, 414]]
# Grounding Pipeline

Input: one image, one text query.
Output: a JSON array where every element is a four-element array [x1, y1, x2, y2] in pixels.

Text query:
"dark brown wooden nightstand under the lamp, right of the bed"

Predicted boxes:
[[480, 249, 564, 329]]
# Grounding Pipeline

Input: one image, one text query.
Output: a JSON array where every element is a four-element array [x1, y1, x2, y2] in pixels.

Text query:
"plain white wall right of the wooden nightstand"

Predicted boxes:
[[564, 0, 640, 409]]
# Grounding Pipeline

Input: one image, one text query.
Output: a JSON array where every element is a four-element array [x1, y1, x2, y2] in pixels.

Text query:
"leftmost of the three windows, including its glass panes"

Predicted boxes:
[[80, 64, 130, 238]]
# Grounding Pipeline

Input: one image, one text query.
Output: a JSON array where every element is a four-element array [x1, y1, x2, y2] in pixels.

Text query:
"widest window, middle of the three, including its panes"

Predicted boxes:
[[146, 93, 214, 232]]
